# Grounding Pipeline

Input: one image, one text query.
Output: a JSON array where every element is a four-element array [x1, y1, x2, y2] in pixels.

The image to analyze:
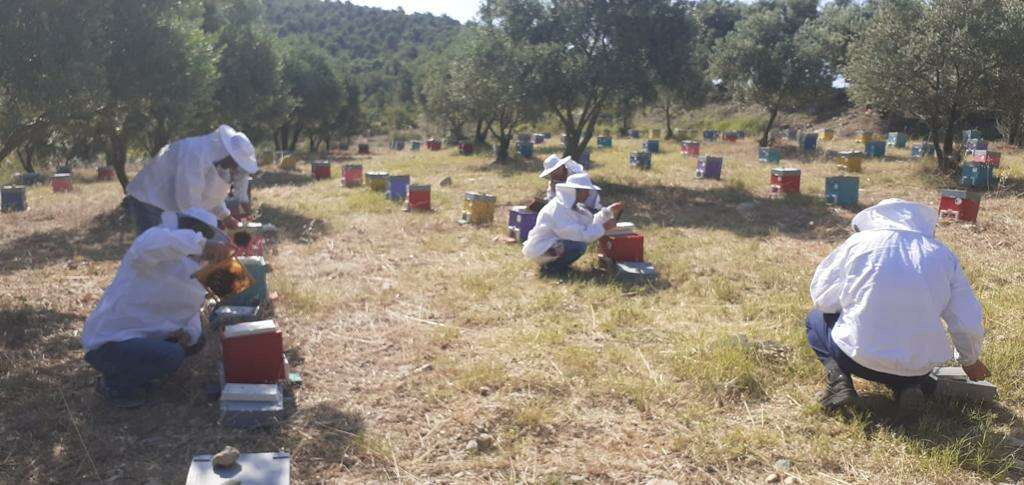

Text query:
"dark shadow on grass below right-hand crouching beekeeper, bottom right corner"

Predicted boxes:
[[847, 393, 1024, 483]]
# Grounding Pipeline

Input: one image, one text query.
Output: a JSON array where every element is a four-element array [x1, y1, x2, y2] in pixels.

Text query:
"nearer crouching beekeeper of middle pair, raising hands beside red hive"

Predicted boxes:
[[522, 173, 623, 274]]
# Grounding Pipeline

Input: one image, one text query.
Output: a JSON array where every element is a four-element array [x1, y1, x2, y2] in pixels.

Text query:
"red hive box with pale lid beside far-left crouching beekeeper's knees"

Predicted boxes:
[[220, 320, 285, 384]]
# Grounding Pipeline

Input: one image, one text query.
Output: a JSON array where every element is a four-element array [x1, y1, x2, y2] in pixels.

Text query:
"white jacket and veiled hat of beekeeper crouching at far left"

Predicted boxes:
[[82, 209, 217, 352]]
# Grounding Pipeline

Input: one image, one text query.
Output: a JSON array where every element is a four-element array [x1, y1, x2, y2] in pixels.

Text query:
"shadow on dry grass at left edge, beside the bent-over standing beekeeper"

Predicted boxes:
[[0, 206, 134, 273]]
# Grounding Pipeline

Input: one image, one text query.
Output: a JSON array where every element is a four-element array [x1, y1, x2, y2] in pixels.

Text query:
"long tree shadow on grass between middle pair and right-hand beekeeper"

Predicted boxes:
[[597, 180, 848, 239]]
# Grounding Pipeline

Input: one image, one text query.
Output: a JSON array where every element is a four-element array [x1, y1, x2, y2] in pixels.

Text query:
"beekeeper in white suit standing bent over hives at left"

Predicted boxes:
[[127, 125, 256, 234]]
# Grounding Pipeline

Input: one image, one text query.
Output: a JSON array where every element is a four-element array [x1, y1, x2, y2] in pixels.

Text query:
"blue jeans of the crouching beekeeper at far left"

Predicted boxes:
[[85, 339, 185, 397]]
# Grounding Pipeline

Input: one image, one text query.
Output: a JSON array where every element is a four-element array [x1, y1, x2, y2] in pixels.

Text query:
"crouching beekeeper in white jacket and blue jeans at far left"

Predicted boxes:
[[82, 209, 232, 407]]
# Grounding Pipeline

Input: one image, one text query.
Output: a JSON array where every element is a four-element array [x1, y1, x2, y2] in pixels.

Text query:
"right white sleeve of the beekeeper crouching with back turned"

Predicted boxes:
[[942, 260, 985, 365]]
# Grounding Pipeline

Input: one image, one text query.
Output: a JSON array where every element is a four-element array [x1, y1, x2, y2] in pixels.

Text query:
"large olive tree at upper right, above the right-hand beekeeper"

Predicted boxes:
[[846, 0, 1017, 172]]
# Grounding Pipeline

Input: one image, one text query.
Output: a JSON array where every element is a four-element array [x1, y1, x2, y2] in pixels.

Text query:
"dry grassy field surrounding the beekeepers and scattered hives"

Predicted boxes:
[[0, 131, 1024, 483]]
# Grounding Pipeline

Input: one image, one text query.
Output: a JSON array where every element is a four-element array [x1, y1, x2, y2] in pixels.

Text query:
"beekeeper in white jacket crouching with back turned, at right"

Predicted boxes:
[[807, 199, 988, 417]]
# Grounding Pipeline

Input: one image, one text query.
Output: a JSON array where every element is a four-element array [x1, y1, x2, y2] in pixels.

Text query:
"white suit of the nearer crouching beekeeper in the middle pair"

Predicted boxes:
[[522, 174, 614, 264]]
